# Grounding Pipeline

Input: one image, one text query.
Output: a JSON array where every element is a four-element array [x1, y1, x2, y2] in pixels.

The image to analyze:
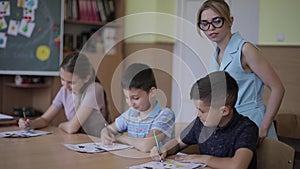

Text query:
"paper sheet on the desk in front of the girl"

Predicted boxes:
[[0, 130, 50, 138]]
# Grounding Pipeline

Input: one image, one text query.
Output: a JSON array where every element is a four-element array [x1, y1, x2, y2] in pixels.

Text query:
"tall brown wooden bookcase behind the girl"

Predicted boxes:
[[64, 0, 125, 121]]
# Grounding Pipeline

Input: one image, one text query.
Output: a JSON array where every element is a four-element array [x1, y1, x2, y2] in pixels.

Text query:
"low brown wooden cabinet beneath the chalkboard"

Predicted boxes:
[[0, 75, 60, 115]]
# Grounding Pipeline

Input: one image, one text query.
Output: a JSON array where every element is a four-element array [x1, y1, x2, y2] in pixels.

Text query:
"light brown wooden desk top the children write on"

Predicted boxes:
[[0, 126, 151, 169]]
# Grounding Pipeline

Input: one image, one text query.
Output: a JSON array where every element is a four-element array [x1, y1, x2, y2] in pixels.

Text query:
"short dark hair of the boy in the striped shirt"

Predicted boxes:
[[121, 63, 157, 93]]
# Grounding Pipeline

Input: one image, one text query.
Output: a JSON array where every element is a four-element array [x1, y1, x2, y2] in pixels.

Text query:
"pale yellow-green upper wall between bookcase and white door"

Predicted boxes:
[[125, 0, 176, 43]]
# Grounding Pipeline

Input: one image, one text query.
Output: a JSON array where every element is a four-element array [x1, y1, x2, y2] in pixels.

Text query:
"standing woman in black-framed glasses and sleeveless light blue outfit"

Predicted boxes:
[[197, 0, 285, 142]]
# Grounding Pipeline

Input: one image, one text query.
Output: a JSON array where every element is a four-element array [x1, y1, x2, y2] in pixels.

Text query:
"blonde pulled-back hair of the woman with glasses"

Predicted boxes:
[[197, 0, 231, 35]]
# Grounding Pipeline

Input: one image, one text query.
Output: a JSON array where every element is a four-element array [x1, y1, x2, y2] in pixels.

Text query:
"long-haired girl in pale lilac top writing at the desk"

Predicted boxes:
[[19, 52, 108, 137]]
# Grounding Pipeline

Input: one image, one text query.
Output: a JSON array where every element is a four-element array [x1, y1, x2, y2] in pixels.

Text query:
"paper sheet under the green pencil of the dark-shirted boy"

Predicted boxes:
[[129, 159, 206, 169]]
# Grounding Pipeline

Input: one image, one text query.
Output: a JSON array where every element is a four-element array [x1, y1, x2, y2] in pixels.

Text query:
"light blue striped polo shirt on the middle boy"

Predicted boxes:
[[115, 101, 175, 144]]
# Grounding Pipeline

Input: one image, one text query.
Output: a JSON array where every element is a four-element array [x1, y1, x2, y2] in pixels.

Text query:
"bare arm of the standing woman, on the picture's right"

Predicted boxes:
[[242, 43, 285, 141]]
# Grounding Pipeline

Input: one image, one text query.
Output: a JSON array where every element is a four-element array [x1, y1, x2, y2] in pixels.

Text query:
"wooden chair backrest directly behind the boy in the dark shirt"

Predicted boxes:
[[257, 137, 295, 169]]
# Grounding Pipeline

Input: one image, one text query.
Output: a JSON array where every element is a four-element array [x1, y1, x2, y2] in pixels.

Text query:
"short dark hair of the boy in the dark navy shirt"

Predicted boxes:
[[190, 71, 238, 107]]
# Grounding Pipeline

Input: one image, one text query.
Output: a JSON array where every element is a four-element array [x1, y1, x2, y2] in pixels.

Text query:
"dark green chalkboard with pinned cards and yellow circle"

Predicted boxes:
[[0, 0, 64, 76]]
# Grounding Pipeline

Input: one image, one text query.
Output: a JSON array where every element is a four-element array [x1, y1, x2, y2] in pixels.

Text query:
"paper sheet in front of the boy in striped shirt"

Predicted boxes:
[[64, 142, 133, 153]]
